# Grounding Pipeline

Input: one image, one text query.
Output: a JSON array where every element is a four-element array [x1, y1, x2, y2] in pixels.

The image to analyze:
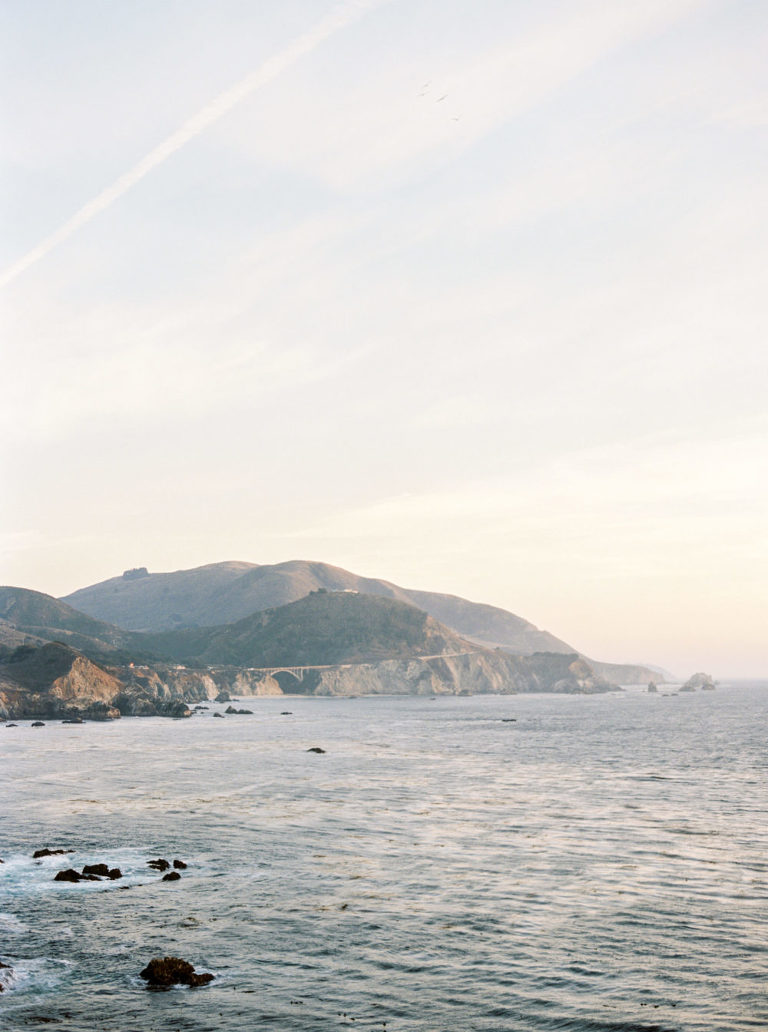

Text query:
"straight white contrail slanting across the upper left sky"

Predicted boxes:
[[0, 0, 386, 287]]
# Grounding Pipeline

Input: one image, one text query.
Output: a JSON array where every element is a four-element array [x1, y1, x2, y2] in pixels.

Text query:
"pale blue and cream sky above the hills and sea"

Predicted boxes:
[[0, 0, 768, 677]]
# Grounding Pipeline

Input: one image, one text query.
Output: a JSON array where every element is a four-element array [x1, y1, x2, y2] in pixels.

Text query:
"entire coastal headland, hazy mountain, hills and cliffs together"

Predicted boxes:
[[0, 560, 661, 719]]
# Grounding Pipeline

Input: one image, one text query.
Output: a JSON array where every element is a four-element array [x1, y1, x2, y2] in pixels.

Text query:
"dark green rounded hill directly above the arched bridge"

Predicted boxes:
[[141, 589, 475, 667]]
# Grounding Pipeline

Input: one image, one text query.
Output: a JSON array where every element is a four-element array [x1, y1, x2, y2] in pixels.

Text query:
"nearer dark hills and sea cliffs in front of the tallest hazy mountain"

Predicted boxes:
[[0, 588, 613, 719]]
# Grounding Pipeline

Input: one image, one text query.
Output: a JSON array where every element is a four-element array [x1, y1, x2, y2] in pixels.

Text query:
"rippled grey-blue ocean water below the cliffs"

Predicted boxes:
[[0, 684, 768, 1032]]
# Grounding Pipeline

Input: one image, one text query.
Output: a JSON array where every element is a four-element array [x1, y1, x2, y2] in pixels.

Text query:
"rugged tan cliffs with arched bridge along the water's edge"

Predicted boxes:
[[0, 642, 615, 723]]
